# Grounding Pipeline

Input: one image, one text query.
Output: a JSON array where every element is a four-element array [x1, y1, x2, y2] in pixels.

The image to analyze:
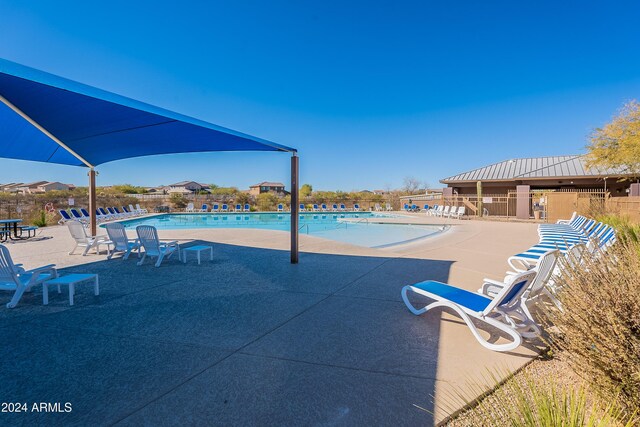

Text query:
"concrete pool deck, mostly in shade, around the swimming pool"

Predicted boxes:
[[0, 214, 537, 426]]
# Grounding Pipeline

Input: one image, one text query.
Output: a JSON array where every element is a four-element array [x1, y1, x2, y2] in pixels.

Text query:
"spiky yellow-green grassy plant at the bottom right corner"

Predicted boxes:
[[449, 373, 637, 427]]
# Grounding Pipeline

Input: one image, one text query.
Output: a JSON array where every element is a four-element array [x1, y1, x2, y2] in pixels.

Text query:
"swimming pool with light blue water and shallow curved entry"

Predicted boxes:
[[114, 212, 443, 248]]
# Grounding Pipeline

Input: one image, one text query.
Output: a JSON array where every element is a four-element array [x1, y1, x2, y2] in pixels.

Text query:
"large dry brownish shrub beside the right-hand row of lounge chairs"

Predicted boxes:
[[545, 239, 640, 412]]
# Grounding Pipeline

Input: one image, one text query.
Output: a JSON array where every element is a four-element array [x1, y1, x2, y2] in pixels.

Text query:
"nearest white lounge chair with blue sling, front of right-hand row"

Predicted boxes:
[[401, 271, 536, 351]]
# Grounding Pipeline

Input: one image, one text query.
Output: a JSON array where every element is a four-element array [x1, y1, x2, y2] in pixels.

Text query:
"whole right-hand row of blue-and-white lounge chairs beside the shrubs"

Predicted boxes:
[[401, 213, 616, 351]]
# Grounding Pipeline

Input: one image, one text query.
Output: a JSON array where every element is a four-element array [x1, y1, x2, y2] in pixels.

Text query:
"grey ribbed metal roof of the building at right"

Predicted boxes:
[[440, 155, 627, 184]]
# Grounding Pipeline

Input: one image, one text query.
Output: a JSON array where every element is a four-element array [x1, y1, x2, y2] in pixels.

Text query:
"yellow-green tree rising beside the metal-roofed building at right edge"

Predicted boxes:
[[587, 101, 640, 176]]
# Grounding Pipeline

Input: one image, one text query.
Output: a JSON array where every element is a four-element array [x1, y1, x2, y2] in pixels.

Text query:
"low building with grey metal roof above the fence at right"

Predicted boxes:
[[440, 155, 633, 196]]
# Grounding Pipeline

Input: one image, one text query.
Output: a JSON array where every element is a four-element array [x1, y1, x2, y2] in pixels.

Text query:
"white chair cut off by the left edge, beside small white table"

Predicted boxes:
[[0, 245, 58, 308]]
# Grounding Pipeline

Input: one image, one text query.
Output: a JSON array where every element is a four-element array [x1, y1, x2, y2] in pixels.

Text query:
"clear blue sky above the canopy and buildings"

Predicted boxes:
[[0, 0, 640, 190]]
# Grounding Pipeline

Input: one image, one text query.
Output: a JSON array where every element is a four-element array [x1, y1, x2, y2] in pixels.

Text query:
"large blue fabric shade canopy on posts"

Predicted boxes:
[[0, 59, 296, 166]]
